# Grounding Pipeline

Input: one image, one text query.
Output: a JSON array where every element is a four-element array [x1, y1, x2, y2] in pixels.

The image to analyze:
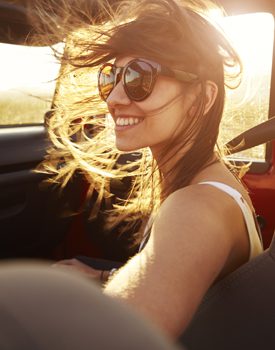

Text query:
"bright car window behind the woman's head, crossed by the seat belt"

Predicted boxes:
[[221, 13, 274, 161]]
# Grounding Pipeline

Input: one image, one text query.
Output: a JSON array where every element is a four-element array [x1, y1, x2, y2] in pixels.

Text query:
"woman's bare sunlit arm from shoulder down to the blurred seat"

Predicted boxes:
[[105, 186, 248, 337]]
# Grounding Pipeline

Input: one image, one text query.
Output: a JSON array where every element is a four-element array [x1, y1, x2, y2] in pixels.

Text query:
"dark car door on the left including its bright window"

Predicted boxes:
[[0, 2, 81, 258]]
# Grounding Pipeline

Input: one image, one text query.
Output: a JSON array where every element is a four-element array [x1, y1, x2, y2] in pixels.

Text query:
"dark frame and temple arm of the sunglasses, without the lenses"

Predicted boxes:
[[98, 58, 199, 102]]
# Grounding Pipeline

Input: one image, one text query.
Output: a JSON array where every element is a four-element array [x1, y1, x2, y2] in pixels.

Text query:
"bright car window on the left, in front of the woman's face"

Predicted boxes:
[[0, 43, 59, 126]]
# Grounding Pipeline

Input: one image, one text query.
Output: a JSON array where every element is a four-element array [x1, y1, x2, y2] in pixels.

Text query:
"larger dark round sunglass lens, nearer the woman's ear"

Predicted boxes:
[[124, 61, 153, 101]]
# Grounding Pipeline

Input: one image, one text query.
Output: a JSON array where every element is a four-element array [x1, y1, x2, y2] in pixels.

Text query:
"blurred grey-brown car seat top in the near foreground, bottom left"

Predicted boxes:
[[0, 261, 183, 350]]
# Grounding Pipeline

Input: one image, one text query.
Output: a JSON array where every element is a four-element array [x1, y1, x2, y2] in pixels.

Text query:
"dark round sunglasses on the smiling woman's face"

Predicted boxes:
[[98, 58, 198, 101]]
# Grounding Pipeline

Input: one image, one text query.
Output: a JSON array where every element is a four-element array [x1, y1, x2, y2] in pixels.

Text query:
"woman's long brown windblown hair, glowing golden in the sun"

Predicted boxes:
[[31, 0, 242, 235]]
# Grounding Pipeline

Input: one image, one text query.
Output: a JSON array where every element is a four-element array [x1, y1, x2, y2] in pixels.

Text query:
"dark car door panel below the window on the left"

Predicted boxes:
[[0, 126, 72, 258]]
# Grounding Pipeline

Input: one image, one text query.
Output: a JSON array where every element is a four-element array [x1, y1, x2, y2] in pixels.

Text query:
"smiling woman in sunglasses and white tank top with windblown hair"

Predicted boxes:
[[40, 0, 262, 337]]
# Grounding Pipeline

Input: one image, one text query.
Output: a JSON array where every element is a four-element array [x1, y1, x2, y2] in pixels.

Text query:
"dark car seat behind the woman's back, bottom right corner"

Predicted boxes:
[[180, 237, 275, 350]]
